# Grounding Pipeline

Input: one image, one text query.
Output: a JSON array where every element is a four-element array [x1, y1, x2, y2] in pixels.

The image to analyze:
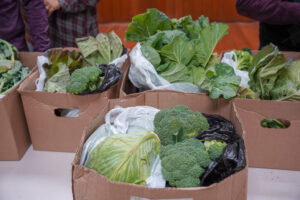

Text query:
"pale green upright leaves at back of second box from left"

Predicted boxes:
[[76, 31, 123, 66]]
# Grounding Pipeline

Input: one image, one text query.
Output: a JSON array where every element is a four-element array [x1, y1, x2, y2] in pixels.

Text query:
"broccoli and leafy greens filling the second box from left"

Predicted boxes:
[[43, 31, 123, 94]]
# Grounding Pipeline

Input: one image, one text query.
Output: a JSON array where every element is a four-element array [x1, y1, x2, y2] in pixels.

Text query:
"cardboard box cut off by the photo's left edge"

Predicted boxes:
[[0, 52, 41, 160]]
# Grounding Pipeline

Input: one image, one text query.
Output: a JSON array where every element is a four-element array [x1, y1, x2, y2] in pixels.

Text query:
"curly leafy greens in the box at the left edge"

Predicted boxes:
[[0, 39, 29, 94]]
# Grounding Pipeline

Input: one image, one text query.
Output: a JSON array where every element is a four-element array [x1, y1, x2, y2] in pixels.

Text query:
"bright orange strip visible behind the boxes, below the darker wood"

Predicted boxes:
[[99, 22, 259, 53]]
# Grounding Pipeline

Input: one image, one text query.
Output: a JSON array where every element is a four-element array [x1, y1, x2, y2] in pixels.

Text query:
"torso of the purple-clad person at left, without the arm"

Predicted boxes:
[[0, 0, 27, 50]]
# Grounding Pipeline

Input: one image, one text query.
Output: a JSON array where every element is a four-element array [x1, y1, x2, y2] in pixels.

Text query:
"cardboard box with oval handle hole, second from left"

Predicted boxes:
[[19, 53, 128, 152]]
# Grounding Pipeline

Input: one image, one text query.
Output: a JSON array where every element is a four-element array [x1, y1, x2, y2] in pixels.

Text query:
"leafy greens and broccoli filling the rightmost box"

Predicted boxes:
[[235, 44, 300, 101]]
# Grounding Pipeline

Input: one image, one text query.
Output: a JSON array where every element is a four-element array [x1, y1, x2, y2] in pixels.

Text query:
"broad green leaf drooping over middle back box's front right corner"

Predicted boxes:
[[200, 63, 241, 99]]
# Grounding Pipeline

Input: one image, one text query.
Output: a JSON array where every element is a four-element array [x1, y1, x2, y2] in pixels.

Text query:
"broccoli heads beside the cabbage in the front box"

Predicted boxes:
[[154, 105, 227, 187]]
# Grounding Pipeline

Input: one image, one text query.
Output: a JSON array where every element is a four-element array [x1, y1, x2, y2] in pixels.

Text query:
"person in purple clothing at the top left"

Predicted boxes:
[[0, 0, 50, 51]]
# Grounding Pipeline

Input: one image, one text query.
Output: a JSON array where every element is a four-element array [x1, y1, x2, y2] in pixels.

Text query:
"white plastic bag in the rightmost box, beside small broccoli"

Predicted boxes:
[[221, 51, 250, 88]]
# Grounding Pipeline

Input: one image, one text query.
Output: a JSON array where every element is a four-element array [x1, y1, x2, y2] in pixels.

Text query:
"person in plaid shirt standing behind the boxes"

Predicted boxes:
[[44, 0, 98, 47]]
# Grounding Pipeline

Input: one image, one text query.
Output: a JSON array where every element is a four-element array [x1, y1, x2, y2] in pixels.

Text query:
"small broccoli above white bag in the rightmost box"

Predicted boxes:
[[234, 50, 253, 71]]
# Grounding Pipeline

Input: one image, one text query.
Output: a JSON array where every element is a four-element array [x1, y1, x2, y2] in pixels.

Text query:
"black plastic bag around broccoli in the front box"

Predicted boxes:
[[197, 114, 246, 186]]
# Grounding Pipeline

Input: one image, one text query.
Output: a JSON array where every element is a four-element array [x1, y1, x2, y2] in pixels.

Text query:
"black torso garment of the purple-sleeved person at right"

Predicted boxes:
[[259, 0, 300, 51]]
